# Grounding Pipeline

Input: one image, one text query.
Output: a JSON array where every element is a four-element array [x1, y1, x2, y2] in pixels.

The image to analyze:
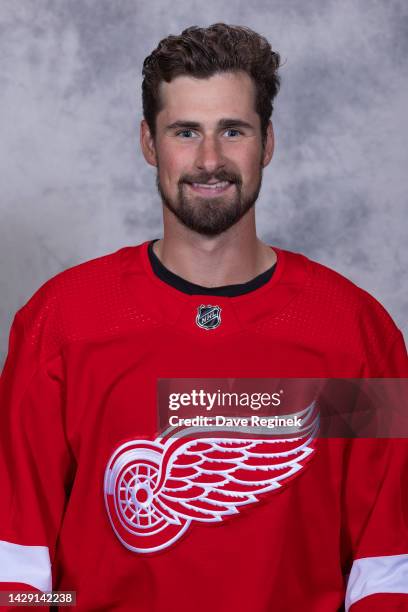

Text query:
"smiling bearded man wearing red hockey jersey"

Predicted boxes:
[[0, 24, 408, 612]]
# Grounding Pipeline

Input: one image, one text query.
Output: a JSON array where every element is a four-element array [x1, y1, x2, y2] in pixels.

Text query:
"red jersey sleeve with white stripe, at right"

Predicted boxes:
[[344, 331, 408, 612]]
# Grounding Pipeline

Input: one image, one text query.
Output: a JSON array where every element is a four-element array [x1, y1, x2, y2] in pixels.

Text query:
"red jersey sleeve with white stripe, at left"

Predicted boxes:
[[0, 314, 73, 610]]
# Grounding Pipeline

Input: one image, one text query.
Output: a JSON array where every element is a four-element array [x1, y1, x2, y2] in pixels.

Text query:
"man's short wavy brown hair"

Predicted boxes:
[[142, 23, 280, 145]]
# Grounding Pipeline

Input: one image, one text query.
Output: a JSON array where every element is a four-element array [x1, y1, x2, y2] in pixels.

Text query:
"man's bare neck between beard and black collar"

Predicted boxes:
[[154, 209, 276, 287]]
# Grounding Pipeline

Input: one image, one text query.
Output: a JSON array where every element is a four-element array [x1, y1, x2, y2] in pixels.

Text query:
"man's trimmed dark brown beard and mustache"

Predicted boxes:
[[156, 165, 262, 236]]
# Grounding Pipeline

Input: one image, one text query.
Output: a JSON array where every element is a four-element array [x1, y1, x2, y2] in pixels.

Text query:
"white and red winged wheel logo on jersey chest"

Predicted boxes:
[[104, 404, 318, 553]]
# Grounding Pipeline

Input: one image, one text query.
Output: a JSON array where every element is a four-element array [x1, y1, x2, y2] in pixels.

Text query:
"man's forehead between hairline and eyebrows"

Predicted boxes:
[[158, 72, 257, 122]]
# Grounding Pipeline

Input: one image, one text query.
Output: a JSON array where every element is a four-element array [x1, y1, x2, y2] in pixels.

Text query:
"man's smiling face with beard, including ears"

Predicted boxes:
[[142, 72, 273, 236]]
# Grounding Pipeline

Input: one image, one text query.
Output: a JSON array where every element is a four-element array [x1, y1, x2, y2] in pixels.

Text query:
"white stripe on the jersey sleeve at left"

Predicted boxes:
[[0, 540, 52, 591]]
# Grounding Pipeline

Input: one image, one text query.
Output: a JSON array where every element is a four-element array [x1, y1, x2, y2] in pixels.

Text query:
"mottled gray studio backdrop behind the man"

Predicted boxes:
[[0, 0, 408, 363]]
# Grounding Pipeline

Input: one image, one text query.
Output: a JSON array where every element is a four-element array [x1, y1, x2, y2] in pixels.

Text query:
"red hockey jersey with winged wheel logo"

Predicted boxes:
[[0, 242, 408, 612]]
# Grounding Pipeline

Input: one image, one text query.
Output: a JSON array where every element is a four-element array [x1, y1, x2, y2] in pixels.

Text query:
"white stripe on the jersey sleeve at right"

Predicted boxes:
[[345, 554, 408, 612]]
